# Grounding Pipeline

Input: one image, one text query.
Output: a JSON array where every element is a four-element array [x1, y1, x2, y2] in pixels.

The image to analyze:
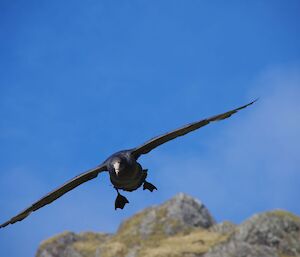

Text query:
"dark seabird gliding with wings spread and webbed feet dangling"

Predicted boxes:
[[0, 100, 256, 228]]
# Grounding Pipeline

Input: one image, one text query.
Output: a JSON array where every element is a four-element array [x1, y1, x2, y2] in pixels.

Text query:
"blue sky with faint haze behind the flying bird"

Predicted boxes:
[[0, 0, 300, 257]]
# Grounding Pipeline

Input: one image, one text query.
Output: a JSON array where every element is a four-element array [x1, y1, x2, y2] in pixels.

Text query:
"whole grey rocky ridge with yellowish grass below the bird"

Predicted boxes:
[[36, 193, 300, 257]]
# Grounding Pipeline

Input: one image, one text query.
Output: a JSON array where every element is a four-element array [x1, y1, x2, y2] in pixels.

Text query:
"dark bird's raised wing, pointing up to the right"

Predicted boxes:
[[132, 99, 257, 159]]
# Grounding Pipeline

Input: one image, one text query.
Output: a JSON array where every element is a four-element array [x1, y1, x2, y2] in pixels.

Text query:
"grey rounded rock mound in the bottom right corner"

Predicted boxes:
[[204, 210, 300, 257]]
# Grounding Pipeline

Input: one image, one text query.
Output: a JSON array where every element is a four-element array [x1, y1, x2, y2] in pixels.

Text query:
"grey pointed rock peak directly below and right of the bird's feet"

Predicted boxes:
[[118, 193, 215, 239]]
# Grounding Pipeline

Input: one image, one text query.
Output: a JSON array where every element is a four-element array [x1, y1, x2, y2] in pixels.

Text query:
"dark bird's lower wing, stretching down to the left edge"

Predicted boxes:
[[0, 164, 106, 228]]
